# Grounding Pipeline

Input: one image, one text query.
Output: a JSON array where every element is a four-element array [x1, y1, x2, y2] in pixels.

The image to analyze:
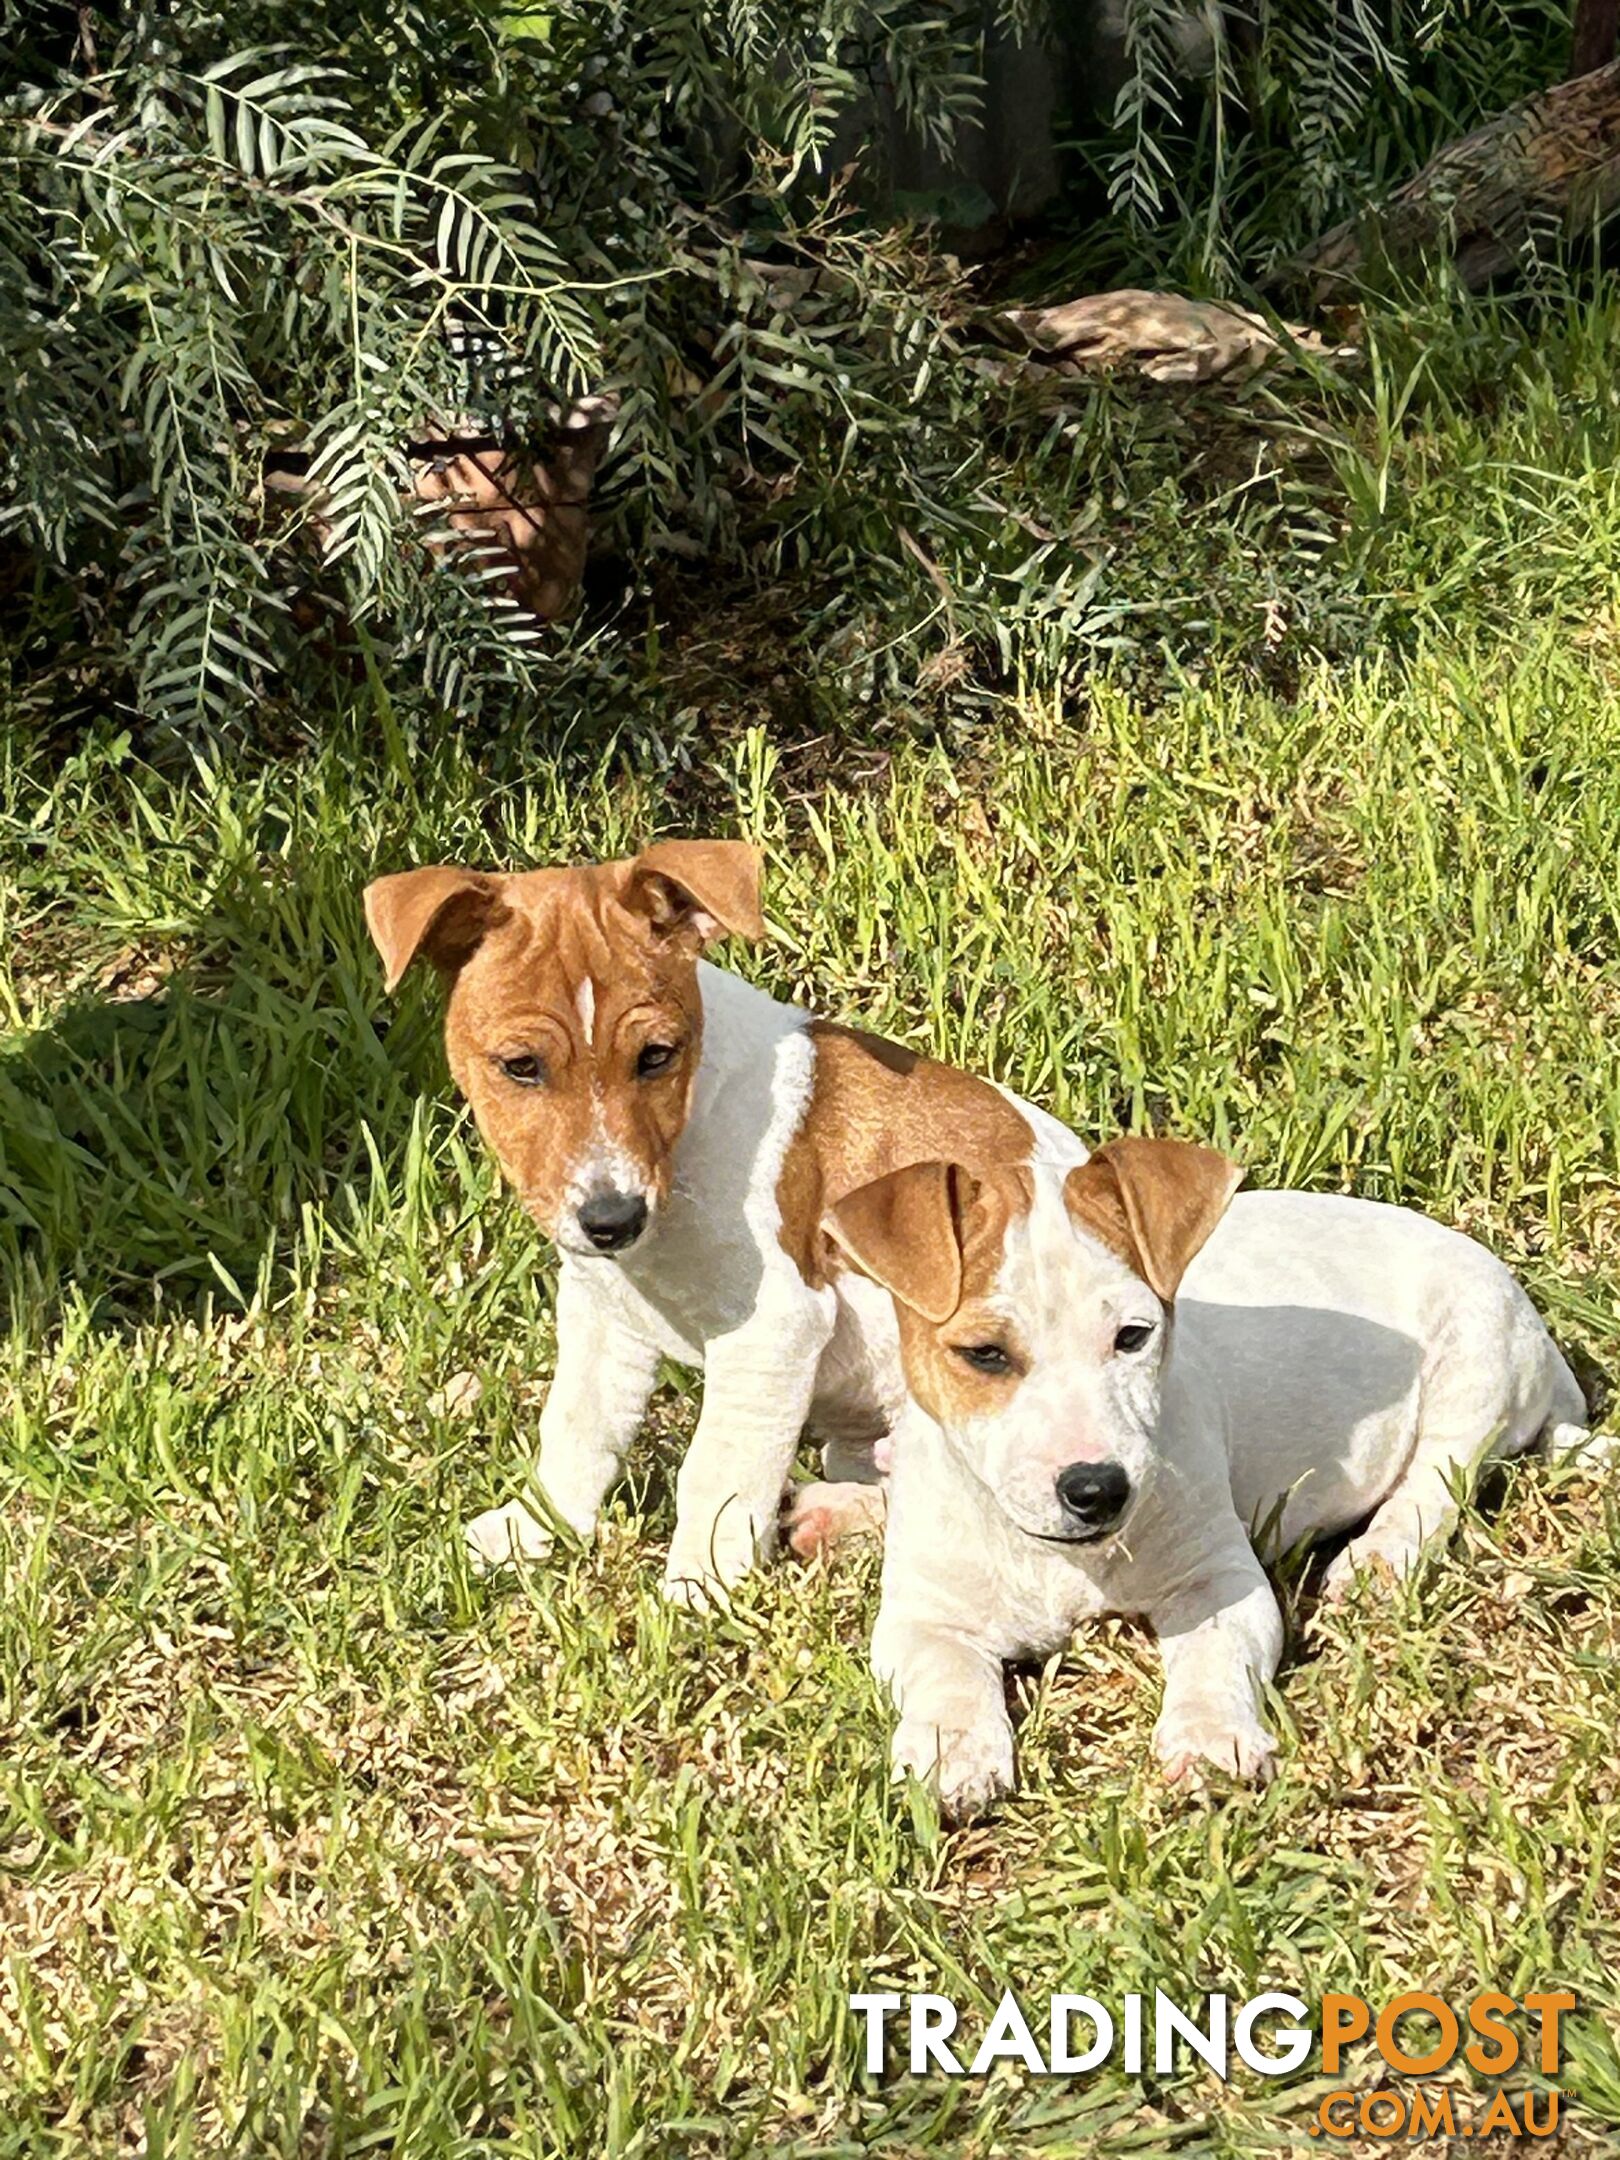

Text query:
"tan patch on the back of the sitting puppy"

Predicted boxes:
[[775, 1020, 1035, 1287]]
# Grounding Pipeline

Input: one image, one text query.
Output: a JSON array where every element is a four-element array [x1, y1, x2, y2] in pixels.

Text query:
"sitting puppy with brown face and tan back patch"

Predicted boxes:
[[365, 840, 1086, 1601]]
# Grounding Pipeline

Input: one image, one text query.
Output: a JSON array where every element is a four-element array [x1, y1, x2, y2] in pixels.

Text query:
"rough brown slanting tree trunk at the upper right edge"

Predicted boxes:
[[1277, 60, 1620, 307]]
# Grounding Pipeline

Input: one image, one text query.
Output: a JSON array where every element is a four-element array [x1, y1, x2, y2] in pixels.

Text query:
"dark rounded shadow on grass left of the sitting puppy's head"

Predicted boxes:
[[0, 968, 425, 1318]]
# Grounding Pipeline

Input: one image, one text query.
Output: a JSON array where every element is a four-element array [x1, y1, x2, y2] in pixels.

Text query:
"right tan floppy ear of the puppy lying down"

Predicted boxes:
[[1063, 1138, 1244, 1305]]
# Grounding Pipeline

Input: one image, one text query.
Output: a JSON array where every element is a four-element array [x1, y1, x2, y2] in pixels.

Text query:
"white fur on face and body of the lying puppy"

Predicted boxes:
[[873, 1177, 1611, 1814]]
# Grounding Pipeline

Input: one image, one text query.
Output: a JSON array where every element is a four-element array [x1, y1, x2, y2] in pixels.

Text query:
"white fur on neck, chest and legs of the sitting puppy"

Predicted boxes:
[[467, 961, 1086, 1603]]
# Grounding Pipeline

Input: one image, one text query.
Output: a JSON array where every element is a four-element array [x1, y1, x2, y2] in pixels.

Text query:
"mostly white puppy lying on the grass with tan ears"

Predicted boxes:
[[827, 1138, 1615, 1817]]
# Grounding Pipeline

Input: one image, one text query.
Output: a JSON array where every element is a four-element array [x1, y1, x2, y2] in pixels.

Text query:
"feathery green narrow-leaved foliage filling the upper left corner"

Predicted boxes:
[[0, 0, 976, 730]]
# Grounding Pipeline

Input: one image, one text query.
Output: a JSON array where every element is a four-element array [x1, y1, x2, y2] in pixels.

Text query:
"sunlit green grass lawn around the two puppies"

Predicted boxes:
[[0, 282, 1620, 2160]]
